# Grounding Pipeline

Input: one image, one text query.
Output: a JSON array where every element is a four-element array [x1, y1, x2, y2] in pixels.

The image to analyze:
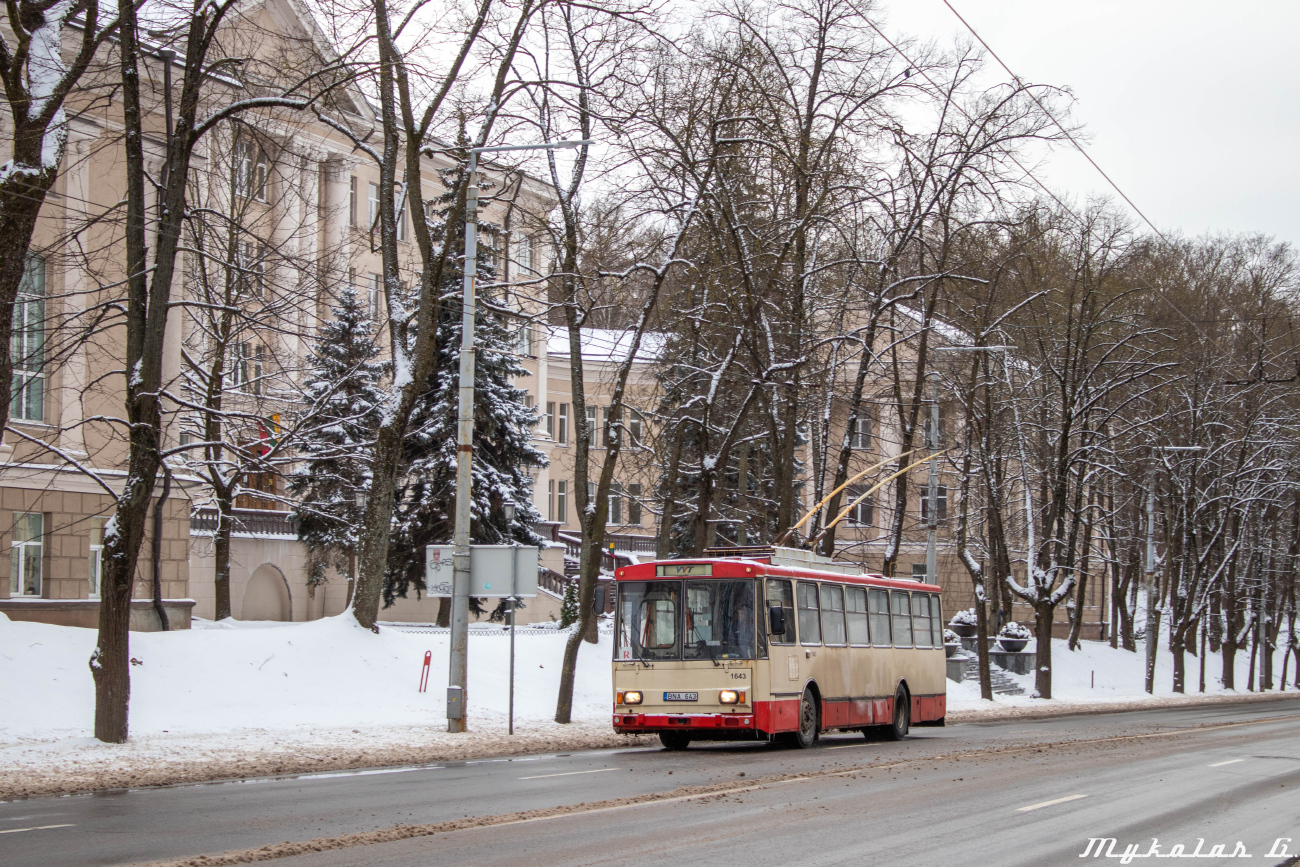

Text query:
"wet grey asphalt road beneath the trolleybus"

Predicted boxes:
[[0, 699, 1300, 867]]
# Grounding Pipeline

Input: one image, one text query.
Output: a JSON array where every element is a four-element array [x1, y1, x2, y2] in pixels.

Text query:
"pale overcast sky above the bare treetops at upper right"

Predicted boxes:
[[880, 0, 1300, 243]]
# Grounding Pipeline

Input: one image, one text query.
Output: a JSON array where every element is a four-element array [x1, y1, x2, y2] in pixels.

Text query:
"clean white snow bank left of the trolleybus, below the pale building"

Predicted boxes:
[[0, 616, 612, 744]]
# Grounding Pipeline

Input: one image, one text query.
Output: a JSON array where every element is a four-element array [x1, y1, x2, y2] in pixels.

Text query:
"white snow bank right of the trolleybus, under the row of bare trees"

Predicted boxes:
[[948, 638, 1295, 711]]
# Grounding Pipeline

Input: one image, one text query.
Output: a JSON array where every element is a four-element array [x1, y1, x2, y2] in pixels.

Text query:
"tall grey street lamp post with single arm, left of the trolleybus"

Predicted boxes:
[[447, 140, 593, 732]]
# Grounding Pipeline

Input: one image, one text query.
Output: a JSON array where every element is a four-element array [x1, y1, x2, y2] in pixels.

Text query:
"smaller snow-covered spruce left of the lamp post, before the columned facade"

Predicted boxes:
[[289, 287, 387, 592]]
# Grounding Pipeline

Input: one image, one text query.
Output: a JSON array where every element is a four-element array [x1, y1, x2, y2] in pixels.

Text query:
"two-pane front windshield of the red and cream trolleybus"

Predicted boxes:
[[615, 580, 755, 662]]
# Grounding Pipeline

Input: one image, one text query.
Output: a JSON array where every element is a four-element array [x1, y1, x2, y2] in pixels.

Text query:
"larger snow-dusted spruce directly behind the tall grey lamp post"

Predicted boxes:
[[384, 170, 547, 613]]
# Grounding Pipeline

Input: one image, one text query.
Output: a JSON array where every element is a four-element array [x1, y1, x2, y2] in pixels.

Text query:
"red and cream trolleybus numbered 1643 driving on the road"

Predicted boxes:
[[614, 549, 946, 750]]
